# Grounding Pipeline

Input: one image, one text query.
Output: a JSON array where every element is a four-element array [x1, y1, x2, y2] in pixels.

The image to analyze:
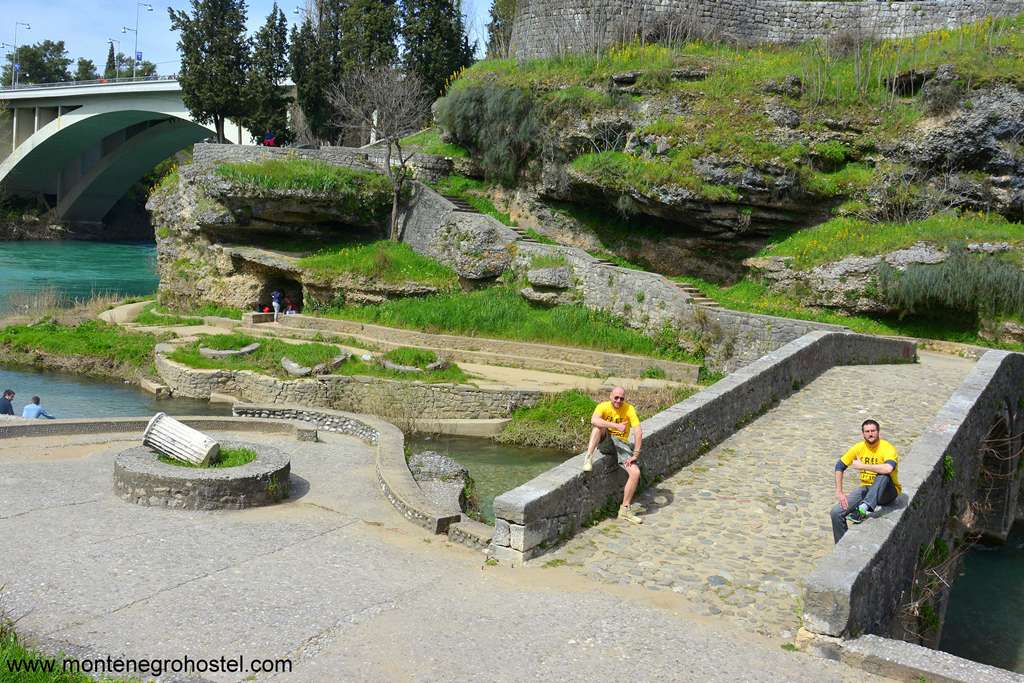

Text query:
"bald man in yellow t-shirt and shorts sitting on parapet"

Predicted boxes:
[[583, 387, 643, 524]]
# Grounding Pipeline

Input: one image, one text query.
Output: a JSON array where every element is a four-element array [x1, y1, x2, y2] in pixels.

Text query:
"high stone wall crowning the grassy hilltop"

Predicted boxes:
[[511, 0, 1024, 58]]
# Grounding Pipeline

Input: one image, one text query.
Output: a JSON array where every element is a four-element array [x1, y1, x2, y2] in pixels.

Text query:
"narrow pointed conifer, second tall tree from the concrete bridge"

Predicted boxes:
[[242, 2, 291, 142]]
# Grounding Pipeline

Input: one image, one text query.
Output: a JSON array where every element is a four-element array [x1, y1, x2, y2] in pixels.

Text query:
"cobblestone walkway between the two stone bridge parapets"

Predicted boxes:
[[539, 353, 973, 639]]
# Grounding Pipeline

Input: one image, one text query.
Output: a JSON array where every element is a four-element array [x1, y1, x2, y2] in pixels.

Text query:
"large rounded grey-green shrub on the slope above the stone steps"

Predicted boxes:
[[437, 82, 541, 184]]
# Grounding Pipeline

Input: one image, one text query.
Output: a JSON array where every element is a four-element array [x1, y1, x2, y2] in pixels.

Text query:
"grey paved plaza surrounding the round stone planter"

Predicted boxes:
[[0, 434, 888, 682]]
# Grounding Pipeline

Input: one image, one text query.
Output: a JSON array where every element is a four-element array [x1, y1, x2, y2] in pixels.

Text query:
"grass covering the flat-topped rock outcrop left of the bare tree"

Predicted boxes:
[[216, 159, 392, 222]]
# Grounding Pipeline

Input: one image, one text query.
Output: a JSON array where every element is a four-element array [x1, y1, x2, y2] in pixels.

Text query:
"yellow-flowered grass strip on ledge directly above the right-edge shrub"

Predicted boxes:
[[760, 213, 1024, 269]]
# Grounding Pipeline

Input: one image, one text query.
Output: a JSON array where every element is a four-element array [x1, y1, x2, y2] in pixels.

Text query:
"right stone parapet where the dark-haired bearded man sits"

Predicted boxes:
[[804, 351, 1024, 642]]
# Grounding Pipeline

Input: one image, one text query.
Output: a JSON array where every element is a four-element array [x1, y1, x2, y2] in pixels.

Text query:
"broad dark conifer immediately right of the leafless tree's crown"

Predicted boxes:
[[401, 0, 476, 96]]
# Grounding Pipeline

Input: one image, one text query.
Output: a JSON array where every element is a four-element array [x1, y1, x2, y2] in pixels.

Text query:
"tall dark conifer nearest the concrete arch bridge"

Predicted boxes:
[[167, 0, 250, 141]]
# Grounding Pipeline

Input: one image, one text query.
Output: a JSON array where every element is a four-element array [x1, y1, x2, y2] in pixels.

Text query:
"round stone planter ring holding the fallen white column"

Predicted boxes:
[[114, 441, 292, 510]]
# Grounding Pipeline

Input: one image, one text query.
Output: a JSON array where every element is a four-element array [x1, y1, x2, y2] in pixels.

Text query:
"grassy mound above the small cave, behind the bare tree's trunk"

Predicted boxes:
[[298, 240, 459, 289]]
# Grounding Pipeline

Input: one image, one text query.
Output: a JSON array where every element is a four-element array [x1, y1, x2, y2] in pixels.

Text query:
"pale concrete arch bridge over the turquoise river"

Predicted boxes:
[[0, 79, 249, 222]]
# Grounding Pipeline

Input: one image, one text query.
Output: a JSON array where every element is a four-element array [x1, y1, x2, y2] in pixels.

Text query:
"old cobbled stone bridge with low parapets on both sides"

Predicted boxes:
[[490, 332, 1024, 681]]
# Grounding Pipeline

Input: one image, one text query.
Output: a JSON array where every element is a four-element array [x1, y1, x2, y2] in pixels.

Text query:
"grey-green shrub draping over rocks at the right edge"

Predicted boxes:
[[878, 244, 1024, 316]]
